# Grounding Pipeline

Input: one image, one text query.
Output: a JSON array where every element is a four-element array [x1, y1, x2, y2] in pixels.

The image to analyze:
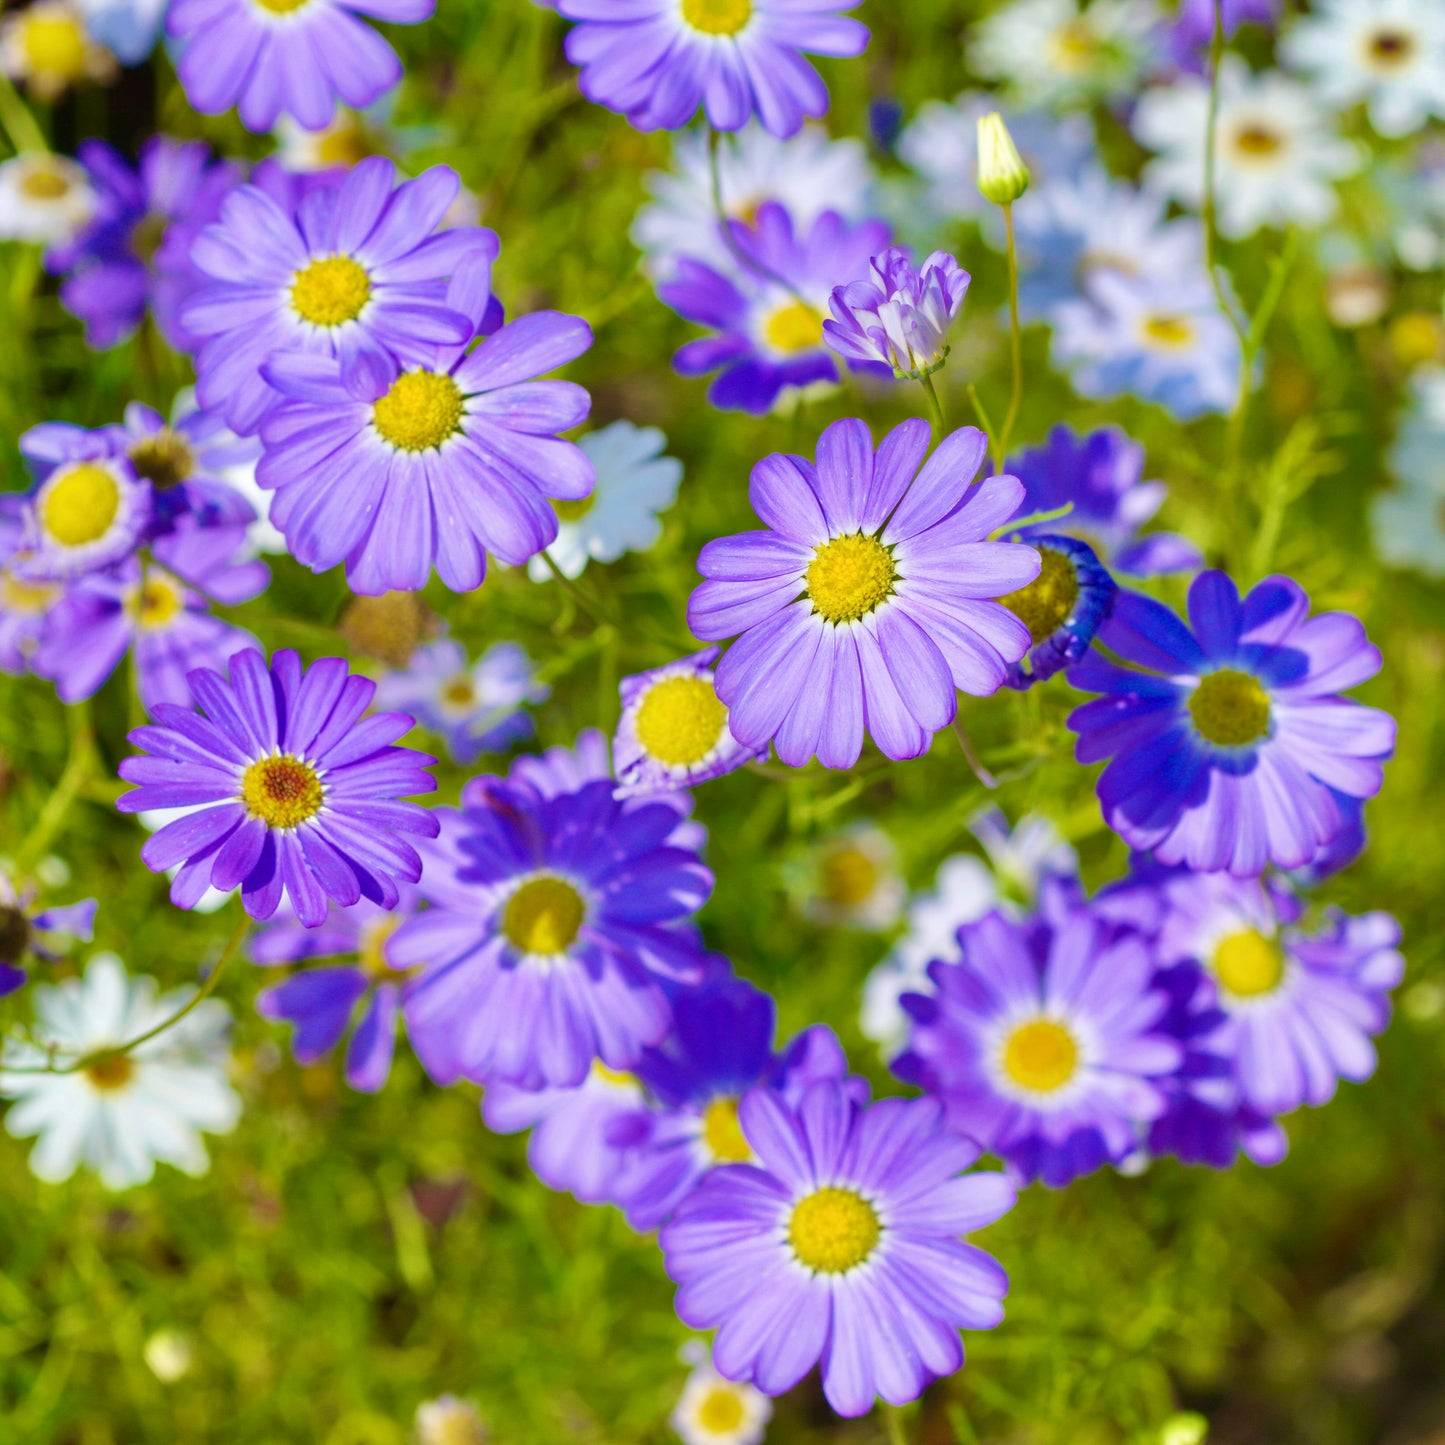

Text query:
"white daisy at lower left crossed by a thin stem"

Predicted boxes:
[[0, 954, 241, 1189]]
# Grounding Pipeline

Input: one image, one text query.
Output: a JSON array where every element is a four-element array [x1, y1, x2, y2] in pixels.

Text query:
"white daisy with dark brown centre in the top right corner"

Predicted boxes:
[[1279, 0, 1445, 136]]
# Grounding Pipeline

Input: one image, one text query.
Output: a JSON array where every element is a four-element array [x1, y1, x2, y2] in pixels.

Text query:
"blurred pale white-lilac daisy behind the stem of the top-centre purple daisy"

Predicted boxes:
[[631, 121, 873, 280]]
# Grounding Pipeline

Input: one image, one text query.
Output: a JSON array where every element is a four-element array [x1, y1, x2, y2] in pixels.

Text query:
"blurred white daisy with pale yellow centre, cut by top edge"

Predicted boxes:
[[968, 0, 1160, 109]]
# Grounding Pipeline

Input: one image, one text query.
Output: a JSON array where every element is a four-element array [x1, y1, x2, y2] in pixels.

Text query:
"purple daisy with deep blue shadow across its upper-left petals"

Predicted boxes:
[[1069, 572, 1394, 877]]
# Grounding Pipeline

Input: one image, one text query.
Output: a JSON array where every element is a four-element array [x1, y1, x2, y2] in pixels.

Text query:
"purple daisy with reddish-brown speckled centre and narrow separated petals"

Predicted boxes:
[[116, 649, 438, 928]]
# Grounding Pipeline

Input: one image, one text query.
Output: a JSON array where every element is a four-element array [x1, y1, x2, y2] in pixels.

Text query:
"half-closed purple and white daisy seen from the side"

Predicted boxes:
[[822, 246, 971, 380]]
